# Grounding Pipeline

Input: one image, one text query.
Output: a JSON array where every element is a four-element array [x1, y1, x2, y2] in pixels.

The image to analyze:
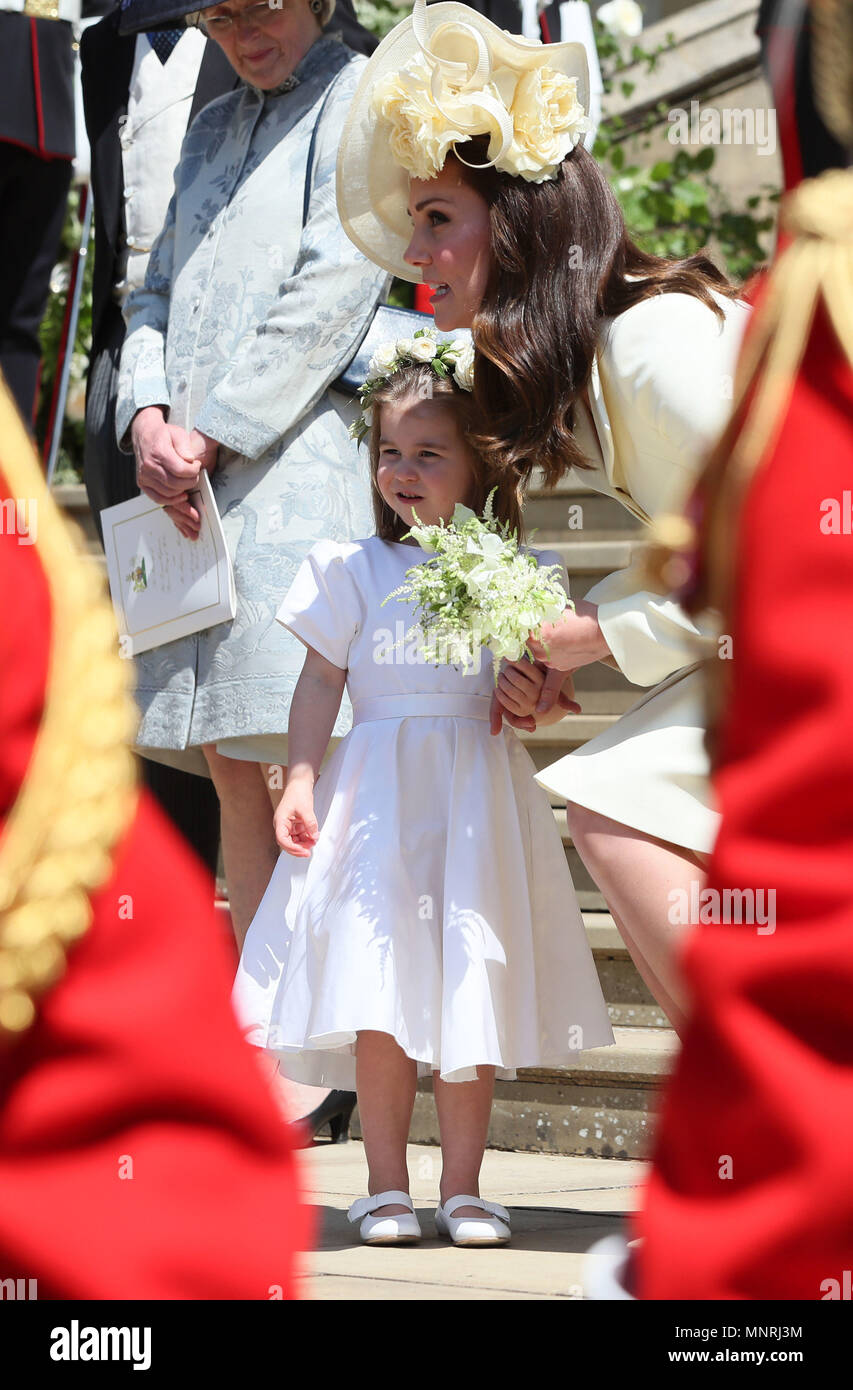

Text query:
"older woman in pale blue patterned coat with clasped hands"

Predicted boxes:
[[117, 0, 386, 956]]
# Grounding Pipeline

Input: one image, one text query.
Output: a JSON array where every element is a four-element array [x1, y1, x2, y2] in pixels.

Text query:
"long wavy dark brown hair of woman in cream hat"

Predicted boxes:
[[447, 136, 738, 487]]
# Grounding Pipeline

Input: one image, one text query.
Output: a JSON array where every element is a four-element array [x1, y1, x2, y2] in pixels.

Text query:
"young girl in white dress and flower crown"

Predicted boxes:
[[235, 348, 614, 1244]]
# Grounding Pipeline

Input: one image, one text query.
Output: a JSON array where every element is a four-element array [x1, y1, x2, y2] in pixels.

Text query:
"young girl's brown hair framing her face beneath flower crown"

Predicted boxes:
[[368, 363, 524, 541]]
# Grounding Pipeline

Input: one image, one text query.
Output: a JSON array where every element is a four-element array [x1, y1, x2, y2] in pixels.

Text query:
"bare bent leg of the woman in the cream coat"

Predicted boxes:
[[567, 802, 704, 1036]]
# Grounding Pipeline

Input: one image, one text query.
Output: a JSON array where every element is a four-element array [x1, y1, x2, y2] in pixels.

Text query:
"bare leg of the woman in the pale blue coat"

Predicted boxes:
[[203, 744, 279, 949]]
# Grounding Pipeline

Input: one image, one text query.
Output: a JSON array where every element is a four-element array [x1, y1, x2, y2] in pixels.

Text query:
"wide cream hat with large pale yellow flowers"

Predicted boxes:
[[336, 0, 590, 284]]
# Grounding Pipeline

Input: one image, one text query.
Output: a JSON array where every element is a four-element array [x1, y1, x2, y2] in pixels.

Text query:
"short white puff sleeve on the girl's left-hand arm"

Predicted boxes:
[[275, 541, 361, 670]]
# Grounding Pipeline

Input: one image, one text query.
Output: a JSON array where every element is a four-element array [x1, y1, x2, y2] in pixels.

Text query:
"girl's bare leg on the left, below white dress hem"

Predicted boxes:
[[356, 1029, 418, 1216]]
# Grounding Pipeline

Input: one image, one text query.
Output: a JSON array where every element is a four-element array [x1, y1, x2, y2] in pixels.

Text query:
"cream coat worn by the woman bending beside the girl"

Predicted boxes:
[[536, 293, 749, 852]]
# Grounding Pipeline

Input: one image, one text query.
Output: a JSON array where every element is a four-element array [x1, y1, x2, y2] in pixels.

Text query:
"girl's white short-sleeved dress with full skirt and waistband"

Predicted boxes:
[[233, 537, 614, 1090]]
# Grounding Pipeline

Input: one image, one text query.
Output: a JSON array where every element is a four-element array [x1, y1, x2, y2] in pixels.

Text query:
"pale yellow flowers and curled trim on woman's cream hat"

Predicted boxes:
[[371, 3, 592, 183]]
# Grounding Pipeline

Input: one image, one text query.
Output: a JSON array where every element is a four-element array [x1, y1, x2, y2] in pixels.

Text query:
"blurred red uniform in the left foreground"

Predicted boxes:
[[0, 375, 310, 1300]]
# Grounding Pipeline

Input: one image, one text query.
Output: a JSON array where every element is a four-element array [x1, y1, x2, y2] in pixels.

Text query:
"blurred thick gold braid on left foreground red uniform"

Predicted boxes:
[[0, 379, 139, 1043]]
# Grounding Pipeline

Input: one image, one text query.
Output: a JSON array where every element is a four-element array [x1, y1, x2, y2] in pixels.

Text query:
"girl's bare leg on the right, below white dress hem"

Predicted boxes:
[[432, 1066, 495, 1220]]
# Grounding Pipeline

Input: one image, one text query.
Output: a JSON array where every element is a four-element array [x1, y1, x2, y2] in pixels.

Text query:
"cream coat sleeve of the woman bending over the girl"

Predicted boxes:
[[586, 295, 749, 685]]
